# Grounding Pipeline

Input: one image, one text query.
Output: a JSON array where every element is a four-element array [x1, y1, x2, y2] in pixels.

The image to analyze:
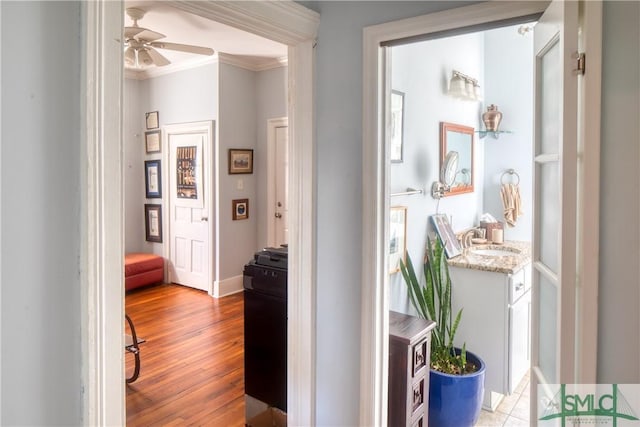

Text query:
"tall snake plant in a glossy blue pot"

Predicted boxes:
[[400, 238, 485, 427]]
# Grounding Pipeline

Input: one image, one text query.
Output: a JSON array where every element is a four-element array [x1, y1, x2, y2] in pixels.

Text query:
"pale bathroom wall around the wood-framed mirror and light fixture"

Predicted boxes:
[[389, 33, 484, 313]]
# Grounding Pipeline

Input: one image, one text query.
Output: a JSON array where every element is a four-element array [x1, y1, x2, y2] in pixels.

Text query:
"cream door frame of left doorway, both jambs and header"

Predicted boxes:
[[79, 0, 319, 426]]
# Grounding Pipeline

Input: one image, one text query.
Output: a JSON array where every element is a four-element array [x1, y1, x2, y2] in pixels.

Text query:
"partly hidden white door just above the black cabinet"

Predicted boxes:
[[267, 118, 289, 247]]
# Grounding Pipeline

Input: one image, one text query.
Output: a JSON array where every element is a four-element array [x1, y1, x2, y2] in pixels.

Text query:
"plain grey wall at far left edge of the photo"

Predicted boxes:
[[0, 2, 84, 426]]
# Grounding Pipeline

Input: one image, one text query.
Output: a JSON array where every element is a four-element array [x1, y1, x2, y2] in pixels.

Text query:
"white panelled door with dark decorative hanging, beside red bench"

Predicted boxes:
[[163, 122, 213, 292]]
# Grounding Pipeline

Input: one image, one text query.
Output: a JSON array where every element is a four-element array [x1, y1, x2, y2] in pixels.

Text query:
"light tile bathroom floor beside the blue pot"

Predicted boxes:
[[476, 373, 529, 427]]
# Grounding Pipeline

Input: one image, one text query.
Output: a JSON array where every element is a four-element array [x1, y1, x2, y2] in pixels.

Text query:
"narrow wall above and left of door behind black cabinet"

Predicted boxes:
[[254, 67, 288, 249]]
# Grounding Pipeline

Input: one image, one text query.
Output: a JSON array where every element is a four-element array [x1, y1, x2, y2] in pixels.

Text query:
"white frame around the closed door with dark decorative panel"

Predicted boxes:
[[162, 120, 218, 296]]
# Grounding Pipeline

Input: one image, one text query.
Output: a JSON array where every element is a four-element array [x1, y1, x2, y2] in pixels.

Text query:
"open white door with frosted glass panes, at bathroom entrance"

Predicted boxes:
[[531, 1, 579, 421]]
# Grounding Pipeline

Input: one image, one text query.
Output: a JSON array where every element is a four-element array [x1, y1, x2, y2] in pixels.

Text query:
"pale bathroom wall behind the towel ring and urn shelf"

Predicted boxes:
[[483, 26, 533, 241]]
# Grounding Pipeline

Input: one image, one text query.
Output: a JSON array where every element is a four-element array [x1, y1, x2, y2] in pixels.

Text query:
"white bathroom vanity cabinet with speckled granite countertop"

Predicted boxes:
[[449, 241, 531, 411]]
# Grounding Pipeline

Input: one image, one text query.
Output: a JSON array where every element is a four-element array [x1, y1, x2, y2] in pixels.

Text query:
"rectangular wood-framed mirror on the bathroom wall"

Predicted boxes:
[[440, 122, 474, 196]]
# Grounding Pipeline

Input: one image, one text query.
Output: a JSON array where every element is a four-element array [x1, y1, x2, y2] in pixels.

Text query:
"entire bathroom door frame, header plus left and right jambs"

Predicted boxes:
[[360, 1, 602, 425]]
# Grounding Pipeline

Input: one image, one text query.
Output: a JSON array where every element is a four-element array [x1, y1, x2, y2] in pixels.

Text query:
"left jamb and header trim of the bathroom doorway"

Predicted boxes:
[[360, 1, 547, 425]]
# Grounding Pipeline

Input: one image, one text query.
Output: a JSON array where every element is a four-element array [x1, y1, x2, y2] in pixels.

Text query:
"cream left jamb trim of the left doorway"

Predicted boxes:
[[80, 0, 125, 426]]
